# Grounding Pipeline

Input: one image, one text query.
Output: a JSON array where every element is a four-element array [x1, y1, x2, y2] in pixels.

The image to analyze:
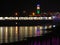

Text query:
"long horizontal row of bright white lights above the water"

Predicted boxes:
[[0, 17, 52, 20]]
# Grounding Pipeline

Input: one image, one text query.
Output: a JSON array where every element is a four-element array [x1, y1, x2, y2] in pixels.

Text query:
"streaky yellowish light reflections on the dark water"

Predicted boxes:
[[0, 25, 52, 43]]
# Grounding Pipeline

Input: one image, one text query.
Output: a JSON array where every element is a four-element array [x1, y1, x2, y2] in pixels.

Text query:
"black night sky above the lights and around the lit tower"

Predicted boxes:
[[0, 0, 60, 15]]
